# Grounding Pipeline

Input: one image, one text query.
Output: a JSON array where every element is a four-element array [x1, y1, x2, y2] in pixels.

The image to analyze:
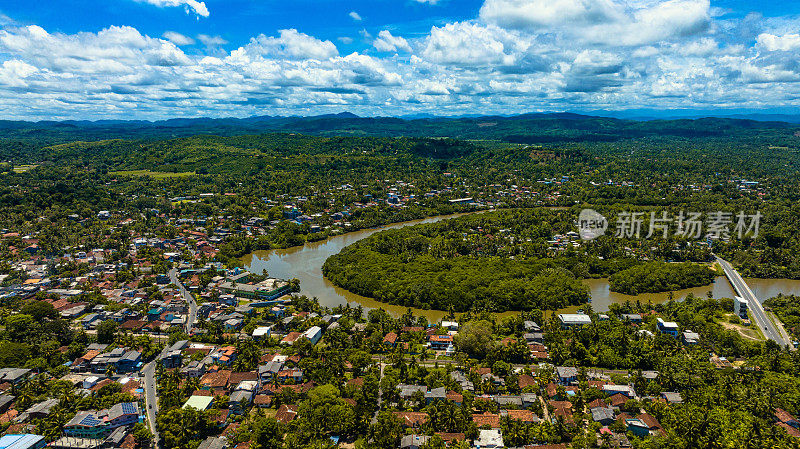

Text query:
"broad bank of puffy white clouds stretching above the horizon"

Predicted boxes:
[[0, 7, 800, 119]]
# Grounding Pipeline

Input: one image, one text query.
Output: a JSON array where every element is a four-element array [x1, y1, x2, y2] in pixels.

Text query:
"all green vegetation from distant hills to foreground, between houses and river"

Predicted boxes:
[[7, 115, 800, 449]]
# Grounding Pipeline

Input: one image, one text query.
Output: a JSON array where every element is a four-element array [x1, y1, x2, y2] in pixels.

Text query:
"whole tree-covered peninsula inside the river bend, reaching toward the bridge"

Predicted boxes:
[[323, 209, 714, 311]]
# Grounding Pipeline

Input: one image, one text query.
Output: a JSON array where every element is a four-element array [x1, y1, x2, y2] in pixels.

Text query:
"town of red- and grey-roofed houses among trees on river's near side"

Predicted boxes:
[[0, 197, 800, 449]]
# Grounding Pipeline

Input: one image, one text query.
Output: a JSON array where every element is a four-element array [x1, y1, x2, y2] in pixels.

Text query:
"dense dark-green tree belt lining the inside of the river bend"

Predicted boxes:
[[323, 245, 589, 312]]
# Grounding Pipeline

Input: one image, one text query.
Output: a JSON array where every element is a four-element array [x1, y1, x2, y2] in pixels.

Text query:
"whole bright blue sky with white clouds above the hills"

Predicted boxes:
[[0, 0, 800, 119]]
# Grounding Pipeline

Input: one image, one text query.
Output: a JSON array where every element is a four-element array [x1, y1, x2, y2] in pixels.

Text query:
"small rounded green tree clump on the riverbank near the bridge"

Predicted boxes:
[[608, 262, 715, 295]]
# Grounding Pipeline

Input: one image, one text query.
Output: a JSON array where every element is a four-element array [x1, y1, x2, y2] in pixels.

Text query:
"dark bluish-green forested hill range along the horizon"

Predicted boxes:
[[0, 113, 800, 157]]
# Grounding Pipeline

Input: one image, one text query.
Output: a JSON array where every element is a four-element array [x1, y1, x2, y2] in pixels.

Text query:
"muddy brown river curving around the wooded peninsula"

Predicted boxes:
[[239, 213, 800, 322]]
